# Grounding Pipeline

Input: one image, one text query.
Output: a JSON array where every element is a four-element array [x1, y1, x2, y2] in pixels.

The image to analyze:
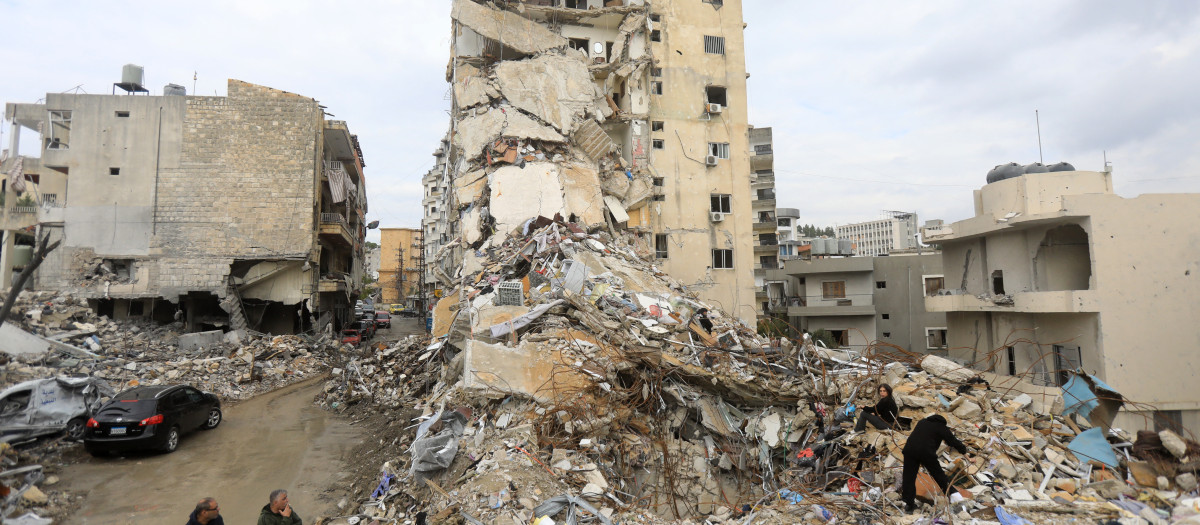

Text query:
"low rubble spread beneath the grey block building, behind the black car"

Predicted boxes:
[[0, 288, 341, 400]]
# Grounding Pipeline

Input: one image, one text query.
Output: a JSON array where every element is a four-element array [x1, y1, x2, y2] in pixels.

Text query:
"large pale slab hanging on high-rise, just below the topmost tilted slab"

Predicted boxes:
[[496, 54, 596, 133]]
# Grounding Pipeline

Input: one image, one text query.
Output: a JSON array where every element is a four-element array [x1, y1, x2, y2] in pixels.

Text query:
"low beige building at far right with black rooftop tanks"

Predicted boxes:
[[924, 167, 1200, 433]]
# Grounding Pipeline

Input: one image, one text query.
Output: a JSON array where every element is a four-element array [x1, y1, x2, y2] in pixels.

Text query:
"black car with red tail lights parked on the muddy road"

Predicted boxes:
[[83, 385, 221, 455]]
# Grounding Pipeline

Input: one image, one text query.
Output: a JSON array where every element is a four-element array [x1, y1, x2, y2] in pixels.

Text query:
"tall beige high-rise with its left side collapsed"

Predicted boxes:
[[422, 0, 758, 321]]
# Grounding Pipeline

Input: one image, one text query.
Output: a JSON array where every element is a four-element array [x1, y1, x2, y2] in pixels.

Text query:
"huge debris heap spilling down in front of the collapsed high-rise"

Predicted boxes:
[[312, 210, 1200, 523]]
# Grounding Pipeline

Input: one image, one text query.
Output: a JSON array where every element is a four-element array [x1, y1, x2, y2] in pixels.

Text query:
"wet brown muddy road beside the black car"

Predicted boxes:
[[62, 379, 361, 524]]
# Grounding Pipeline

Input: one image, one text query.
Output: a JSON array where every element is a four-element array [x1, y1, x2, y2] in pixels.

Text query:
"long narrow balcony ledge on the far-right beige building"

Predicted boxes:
[[925, 290, 1100, 314]]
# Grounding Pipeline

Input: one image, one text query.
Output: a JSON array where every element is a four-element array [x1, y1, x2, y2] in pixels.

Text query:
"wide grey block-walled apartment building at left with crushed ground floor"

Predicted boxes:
[[2, 73, 367, 333]]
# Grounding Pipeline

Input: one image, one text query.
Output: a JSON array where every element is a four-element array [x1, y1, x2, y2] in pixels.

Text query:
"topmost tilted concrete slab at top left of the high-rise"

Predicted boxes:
[[450, 0, 566, 55]]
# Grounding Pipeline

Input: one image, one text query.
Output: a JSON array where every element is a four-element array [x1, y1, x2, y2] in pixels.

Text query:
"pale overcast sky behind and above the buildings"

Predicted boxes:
[[0, 0, 1200, 237]]
